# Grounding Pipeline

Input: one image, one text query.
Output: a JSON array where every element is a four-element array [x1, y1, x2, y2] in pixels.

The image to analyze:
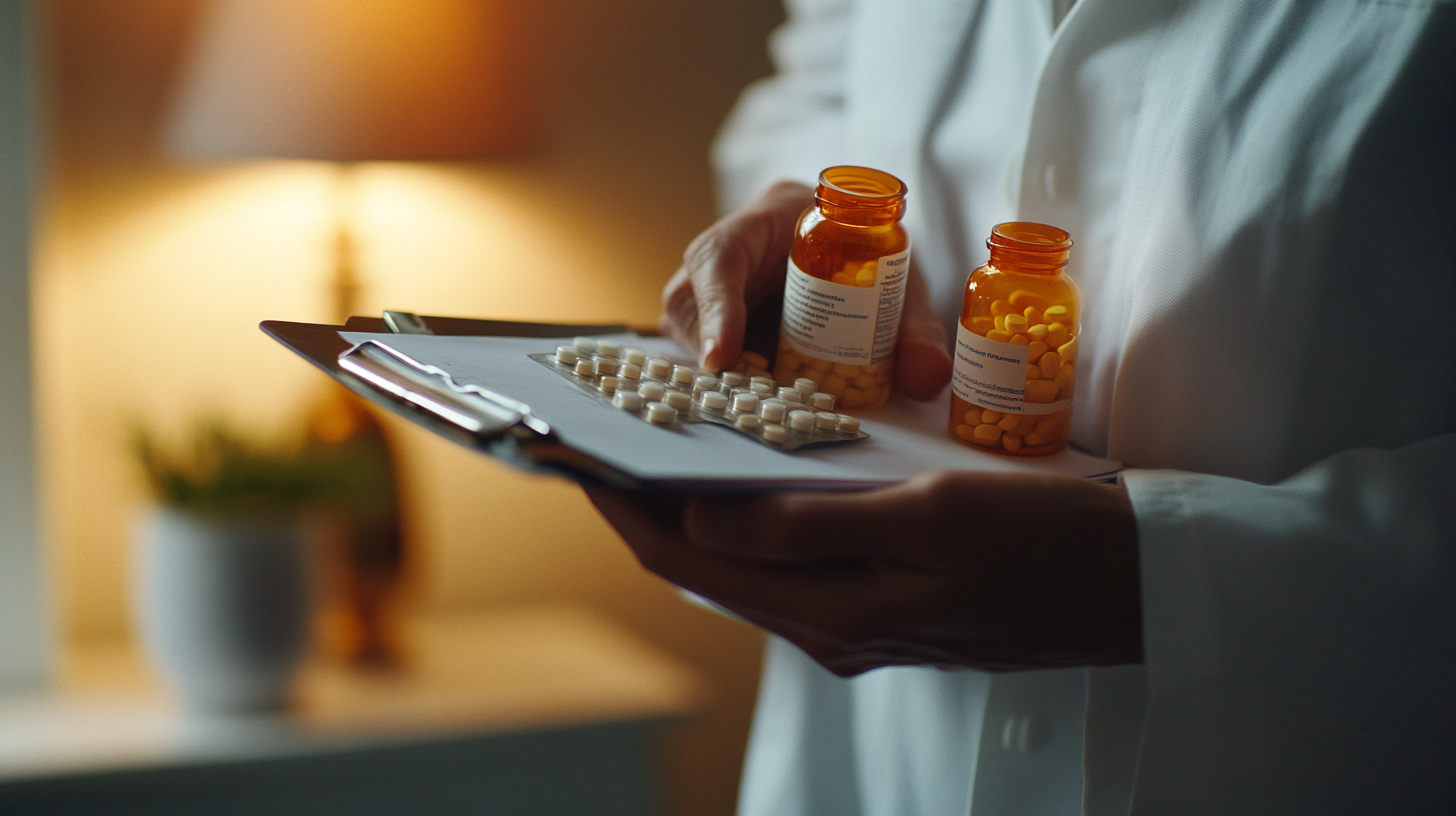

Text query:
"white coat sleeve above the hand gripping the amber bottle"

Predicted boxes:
[[713, 0, 853, 213]]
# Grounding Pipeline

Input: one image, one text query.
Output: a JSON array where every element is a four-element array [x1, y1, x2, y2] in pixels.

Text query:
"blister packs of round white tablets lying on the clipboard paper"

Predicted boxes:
[[529, 337, 869, 450]]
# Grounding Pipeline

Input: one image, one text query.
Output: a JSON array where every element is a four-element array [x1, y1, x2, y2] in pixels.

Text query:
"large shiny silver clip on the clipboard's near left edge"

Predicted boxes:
[[339, 340, 642, 488]]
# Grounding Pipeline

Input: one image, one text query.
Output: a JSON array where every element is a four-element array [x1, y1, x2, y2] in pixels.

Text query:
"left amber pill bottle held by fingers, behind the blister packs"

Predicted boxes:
[[773, 166, 910, 411]]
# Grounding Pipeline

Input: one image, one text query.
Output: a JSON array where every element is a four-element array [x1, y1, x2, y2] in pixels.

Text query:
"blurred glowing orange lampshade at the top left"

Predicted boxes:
[[170, 0, 531, 160]]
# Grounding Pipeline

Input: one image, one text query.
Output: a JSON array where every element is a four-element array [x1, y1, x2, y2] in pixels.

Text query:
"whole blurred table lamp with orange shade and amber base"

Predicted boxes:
[[163, 0, 531, 664]]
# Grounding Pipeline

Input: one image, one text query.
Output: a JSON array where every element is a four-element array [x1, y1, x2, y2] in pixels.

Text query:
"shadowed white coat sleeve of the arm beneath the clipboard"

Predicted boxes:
[[1125, 434, 1456, 813]]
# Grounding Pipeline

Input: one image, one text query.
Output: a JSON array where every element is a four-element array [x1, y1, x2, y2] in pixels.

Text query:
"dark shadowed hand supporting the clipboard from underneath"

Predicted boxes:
[[587, 472, 1143, 678]]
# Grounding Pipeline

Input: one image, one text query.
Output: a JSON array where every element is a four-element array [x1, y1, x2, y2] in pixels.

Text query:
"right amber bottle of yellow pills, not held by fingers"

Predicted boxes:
[[951, 221, 1082, 456]]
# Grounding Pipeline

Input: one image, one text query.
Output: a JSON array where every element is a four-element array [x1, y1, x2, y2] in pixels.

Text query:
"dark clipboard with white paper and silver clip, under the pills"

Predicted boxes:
[[261, 312, 1121, 494]]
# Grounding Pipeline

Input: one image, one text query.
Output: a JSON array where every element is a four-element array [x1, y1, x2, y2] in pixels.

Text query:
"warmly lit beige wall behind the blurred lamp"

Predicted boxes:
[[35, 0, 779, 813]]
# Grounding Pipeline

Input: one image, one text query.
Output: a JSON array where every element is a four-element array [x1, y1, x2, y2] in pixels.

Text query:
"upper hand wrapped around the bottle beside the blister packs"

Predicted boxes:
[[658, 182, 951, 399]]
